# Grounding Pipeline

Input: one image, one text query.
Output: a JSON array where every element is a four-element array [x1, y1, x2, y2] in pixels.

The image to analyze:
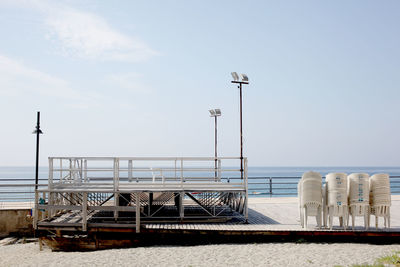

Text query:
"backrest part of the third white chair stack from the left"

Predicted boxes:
[[347, 173, 369, 205]]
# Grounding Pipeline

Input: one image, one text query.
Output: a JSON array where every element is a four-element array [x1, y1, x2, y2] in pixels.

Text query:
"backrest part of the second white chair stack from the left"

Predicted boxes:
[[325, 173, 348, 206]]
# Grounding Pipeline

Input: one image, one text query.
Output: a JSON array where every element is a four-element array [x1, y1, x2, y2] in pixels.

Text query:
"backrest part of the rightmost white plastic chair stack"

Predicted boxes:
[[369, 173, 391, 206]]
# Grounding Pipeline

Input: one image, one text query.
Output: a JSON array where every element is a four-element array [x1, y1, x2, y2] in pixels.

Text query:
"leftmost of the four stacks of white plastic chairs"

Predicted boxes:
[[298, 172, 322, 228]]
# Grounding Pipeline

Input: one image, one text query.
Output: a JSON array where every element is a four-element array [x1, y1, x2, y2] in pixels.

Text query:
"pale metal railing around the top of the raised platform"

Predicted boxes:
[[49, 157, 247, 190]]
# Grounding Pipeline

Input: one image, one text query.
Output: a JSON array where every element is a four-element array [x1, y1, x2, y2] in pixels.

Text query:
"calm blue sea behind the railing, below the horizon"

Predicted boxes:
[[0, 167, 400, 202]]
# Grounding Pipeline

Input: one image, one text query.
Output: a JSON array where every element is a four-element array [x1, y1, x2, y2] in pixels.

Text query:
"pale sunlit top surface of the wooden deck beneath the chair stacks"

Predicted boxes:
[[142, 196, 400, 233]]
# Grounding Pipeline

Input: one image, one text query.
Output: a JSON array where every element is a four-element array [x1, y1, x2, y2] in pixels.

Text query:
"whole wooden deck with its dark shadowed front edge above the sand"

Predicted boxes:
[[38, 196, 400, 250]]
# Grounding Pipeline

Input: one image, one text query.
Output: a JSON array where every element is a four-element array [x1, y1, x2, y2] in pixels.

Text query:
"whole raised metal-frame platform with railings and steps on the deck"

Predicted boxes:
[[34, 157, 248, 232]]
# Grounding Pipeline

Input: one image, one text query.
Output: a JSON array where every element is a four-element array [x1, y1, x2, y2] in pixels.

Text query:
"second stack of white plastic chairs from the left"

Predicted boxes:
[[324, 173, 348, 230]]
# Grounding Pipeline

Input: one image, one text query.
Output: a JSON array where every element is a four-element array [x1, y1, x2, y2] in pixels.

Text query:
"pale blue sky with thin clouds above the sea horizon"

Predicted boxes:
[[0, 0, 400, 166]]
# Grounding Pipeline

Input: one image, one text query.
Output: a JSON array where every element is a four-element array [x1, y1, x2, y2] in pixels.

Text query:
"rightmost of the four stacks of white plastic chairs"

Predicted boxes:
[[369, 173, 391, 228]]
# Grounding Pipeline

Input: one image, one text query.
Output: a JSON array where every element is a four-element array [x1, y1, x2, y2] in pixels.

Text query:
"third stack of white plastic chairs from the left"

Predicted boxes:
[[347, 173, 369, 230]]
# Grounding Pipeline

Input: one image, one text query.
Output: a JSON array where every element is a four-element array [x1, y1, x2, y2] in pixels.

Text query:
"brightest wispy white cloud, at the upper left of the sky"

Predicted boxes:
[[35, 2, 158, 62]]
